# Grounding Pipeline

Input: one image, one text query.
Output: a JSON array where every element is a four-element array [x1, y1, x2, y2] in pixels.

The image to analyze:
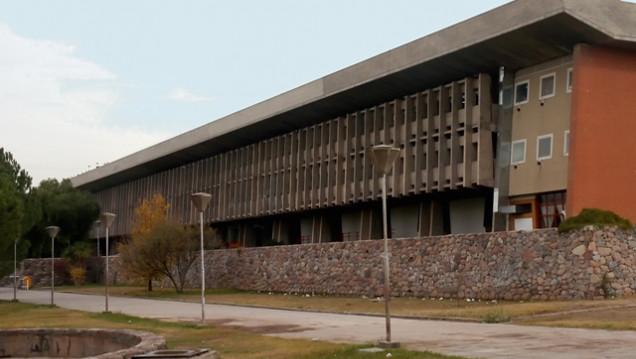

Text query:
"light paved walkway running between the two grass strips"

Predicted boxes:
[[0, 288, 636, 359]]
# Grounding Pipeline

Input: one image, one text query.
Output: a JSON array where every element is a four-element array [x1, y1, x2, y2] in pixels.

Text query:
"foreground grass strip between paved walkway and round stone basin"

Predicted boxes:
[[0, 301, 461, 359]]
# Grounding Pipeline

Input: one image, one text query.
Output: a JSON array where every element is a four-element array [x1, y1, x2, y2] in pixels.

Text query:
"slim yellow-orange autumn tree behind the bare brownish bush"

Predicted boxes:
[[118, 194, 170, 292]]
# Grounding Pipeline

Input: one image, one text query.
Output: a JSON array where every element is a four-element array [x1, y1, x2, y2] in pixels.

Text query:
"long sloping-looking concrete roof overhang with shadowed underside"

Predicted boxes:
[[71, 0, 636, 192]]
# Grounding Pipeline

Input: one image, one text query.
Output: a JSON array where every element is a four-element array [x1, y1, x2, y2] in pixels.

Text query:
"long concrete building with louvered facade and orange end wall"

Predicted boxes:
[[72, 0, 636, 246]]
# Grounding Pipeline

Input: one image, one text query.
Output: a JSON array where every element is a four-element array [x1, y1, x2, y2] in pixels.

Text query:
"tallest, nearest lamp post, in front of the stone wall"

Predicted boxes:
[[369, 145, 400, 347]]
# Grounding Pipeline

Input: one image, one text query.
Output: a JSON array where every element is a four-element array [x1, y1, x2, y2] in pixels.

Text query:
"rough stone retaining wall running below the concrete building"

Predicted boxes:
[[8, 228, 636, 300]]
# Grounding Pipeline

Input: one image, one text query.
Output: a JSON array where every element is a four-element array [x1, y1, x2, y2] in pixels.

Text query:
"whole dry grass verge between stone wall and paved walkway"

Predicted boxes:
[[56, 286, 636, 330]]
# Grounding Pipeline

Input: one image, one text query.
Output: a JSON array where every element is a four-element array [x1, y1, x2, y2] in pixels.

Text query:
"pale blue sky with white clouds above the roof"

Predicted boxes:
[[0, 0, 508, 185]]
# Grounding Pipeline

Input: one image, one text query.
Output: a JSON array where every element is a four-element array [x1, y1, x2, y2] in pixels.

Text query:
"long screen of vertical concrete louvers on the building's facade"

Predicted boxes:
[[96, 74, 496, 235]]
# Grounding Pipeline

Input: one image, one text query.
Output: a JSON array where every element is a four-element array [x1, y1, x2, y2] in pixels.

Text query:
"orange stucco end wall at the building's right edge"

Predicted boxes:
[[567, 45, 636, 222]]
